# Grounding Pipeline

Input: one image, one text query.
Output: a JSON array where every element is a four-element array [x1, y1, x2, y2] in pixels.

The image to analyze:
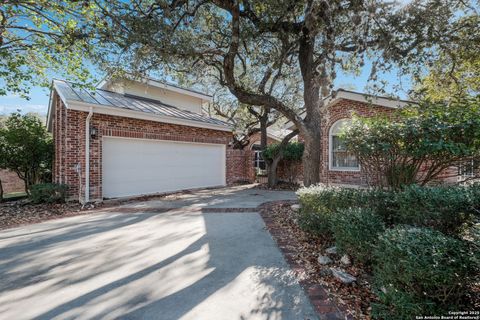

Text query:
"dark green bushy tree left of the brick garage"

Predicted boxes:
[[0, 113, 53, 192]]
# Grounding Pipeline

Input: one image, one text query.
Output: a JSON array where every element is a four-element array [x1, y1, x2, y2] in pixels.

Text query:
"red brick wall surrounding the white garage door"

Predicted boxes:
[[52, 96, 237, 201]]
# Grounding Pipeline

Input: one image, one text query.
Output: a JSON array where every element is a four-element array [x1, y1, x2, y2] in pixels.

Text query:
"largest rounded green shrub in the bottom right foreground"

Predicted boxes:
[[373, 226, 478, 319]]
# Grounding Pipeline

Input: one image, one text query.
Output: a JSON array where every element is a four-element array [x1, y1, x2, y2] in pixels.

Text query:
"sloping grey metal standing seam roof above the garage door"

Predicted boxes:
[[54, 80, 230, 127]]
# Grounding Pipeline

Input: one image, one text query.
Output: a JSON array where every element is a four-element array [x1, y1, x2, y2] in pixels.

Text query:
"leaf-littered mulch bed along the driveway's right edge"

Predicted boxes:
[[259, 201, 375, 319]]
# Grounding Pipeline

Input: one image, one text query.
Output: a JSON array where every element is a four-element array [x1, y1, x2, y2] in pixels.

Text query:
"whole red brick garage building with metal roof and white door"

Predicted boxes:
[[47, 79, 251, 202]]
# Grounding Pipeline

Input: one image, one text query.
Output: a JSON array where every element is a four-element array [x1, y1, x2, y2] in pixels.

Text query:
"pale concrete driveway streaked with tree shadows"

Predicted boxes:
[[0, 187, 316, 320]]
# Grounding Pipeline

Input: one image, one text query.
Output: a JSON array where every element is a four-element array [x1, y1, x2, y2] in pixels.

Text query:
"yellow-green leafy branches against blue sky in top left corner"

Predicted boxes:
[[0, 0, 97, 97]]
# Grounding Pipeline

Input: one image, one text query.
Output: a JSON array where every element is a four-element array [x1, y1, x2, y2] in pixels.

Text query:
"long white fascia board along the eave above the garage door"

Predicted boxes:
[[66, 99, 232, 132]]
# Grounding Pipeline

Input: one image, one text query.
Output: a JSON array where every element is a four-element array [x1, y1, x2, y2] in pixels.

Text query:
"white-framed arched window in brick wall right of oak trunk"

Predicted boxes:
[[329, 119, 360, 171]]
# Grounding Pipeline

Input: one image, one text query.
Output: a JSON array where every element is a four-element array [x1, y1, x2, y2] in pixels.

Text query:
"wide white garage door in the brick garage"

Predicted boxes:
[[102, 137, 225, 198]]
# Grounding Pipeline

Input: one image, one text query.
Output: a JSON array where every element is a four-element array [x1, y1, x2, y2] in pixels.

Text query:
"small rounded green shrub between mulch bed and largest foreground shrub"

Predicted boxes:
[[330, 208, 385, 263]]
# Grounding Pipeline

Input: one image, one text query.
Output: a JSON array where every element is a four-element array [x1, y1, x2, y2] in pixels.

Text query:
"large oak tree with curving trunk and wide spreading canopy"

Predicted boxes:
[[79, 0, 476, 185]]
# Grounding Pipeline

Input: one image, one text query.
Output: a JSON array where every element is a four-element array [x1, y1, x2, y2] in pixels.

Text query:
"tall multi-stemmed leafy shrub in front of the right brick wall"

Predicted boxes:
[[343, 97, 480, 189]]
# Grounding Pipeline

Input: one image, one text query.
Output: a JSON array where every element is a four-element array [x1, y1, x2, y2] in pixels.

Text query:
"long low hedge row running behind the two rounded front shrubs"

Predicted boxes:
[[297, 184, 480, 235]]
